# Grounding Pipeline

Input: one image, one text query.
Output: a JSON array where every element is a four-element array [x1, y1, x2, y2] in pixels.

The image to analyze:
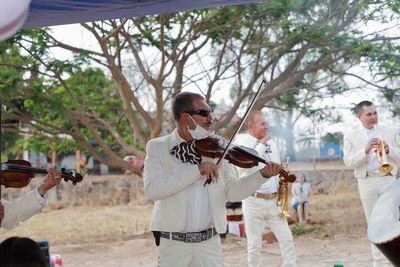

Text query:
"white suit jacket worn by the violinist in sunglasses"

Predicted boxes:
[[144, 129, 266, 233]]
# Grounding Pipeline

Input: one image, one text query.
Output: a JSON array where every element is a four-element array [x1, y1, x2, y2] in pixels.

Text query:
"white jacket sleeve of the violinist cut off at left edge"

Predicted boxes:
[[1, 188, 43, 229]]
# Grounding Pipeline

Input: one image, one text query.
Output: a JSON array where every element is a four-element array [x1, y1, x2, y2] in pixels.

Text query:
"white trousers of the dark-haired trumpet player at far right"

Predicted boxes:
[[358, 176, 396, 267]]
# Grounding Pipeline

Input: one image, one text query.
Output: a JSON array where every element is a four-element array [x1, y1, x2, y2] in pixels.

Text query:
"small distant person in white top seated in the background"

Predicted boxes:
[[292, 174, 311, 223]]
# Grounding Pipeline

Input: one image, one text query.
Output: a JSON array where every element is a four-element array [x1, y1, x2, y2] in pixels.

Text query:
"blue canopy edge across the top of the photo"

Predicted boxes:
[[23, 0, 262, 28]]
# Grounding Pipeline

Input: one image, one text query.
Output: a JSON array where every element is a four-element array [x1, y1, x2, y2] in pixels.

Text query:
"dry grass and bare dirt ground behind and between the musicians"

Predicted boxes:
[[0, 162, 382, 267]]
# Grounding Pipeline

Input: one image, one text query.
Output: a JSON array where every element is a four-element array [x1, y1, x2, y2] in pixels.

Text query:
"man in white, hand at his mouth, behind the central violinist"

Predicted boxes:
[[235, 110, 297, 267]]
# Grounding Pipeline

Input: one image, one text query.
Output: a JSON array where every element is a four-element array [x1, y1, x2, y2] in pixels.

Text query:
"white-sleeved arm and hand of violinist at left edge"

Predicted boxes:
[[0, 167, 61, 229]]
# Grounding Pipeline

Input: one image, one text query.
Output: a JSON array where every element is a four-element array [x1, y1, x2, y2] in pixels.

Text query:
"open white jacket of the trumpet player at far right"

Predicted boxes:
[[343, 126, 400, 178]]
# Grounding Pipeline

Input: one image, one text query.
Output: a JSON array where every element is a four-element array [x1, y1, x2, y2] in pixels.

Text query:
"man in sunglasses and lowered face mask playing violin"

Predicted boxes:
[[144, 92, 282, 267]]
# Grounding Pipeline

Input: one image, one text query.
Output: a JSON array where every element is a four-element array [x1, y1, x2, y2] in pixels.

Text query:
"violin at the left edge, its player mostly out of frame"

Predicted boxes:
[[0, 160, 83, 188]]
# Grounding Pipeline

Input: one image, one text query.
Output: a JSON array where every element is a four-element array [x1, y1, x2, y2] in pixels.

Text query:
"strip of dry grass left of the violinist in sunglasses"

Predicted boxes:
[[0, 202, 152, 245]]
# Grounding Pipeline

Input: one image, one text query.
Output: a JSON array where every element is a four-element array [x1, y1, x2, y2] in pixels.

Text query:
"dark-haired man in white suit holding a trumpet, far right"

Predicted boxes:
[[343, 101, 400, 267]]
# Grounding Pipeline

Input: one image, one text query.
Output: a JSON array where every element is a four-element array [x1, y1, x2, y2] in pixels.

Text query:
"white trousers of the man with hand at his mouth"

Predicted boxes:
[[242, 197, 297, 267]]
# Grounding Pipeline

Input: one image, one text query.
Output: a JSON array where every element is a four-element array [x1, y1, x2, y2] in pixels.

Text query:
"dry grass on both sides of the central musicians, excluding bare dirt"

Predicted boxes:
[[0, 164, 366, 248]]
